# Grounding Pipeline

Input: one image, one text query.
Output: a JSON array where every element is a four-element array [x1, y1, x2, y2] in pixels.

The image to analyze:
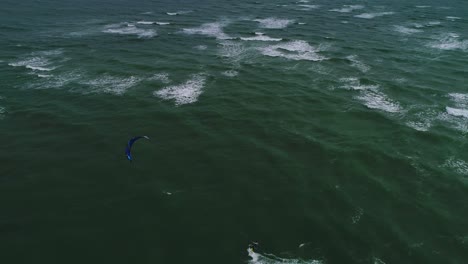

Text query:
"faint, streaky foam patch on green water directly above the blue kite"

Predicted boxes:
[[82, 75, 141, 95]]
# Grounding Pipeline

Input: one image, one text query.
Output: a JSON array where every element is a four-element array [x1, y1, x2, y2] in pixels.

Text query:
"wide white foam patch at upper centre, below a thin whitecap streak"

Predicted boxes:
[[260, 40, 326, 61]]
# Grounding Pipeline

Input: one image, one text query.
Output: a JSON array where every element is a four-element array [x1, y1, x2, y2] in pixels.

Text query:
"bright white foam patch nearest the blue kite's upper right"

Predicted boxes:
[[153, 74, 206, 106]]
